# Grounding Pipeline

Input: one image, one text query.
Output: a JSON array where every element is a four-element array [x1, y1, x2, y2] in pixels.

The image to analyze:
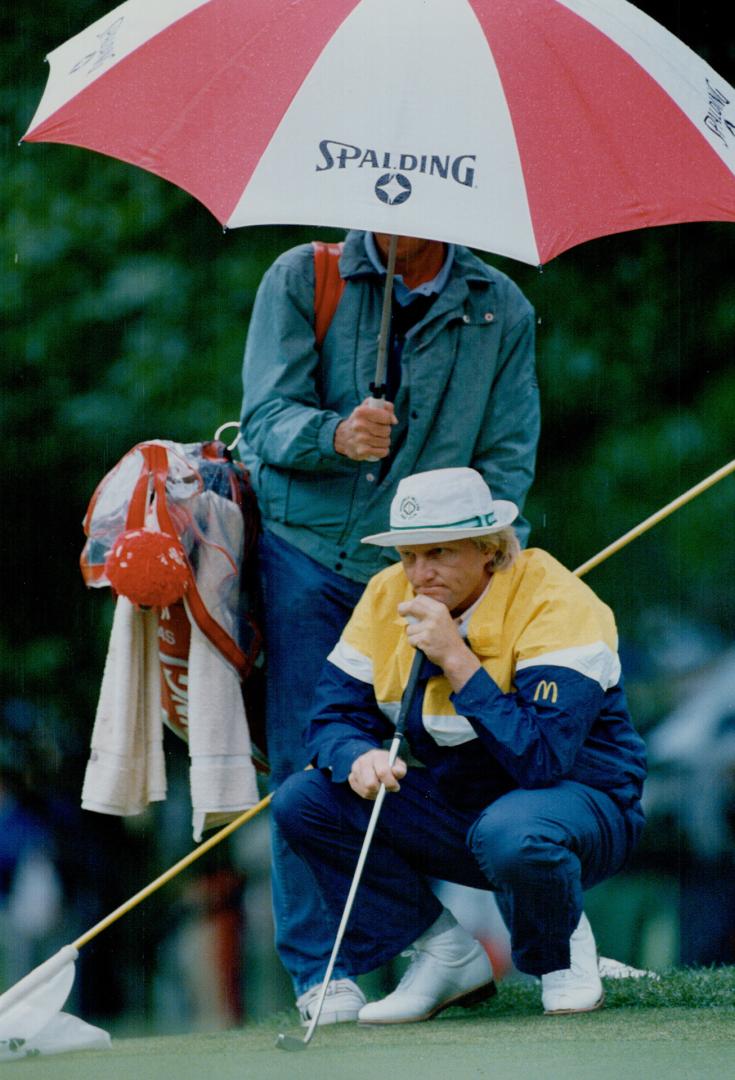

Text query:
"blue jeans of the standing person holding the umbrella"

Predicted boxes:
[[258, 530, 365, 995]]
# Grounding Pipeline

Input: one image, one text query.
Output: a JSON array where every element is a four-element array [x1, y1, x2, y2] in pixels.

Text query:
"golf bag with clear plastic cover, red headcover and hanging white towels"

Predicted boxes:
[[81, 440, 261, 838]]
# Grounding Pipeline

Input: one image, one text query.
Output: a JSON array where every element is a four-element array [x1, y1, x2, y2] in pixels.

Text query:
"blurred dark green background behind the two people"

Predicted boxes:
[[0, 0, 735, 1028]]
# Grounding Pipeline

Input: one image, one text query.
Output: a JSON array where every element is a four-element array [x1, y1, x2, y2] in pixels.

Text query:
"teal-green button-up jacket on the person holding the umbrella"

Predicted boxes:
[[240, 232, 539, 581]]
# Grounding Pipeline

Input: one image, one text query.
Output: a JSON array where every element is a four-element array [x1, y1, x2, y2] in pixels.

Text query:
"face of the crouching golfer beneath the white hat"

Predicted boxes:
[[398, 540, 493, 615]]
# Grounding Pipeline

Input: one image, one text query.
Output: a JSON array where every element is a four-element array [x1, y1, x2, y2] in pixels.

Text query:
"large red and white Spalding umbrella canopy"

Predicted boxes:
[[24, 0, 735, 265]]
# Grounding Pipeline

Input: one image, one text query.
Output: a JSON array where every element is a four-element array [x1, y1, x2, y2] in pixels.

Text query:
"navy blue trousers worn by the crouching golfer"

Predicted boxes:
[[272, 768, 642, 975]]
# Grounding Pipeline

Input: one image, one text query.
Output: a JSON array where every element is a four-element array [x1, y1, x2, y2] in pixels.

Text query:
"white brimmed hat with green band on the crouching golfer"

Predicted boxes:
[[362, 469, 518, 548]]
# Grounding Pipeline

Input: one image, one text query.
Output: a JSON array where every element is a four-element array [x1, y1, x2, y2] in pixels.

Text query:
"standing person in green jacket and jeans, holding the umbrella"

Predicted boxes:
[[240, 230, 539, 1023]]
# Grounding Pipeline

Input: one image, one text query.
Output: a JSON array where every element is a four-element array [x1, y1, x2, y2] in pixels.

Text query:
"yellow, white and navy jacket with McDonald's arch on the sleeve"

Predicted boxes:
[[309, 549, 645, 808]]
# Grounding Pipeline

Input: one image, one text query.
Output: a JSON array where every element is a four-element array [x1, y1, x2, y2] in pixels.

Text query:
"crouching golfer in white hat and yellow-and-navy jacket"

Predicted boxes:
[[273, 469, 645, 1024]]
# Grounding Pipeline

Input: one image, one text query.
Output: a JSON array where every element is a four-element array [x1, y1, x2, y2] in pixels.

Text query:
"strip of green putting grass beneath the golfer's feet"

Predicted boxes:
[[11, 968, 735, 1080]]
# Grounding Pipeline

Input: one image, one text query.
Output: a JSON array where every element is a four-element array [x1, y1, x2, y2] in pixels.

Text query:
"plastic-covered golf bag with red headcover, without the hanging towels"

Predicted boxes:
[[80, 440, 267, 770]]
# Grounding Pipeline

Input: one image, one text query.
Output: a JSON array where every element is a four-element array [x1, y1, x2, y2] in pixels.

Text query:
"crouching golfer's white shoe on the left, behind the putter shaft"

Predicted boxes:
[[357, 910, 496, 1024]]
